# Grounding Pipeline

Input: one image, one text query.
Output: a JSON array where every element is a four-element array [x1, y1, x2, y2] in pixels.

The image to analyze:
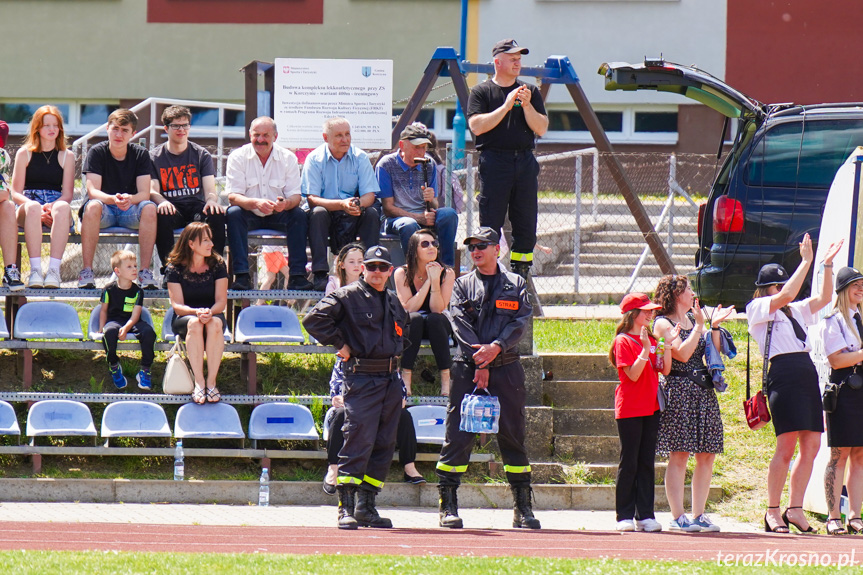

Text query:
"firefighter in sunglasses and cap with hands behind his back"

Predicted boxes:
[[303, 246, 408, 529]]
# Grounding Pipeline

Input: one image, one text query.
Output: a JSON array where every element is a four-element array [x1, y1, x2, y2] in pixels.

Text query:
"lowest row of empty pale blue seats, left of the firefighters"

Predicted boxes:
[[0, 399, 320, 446]]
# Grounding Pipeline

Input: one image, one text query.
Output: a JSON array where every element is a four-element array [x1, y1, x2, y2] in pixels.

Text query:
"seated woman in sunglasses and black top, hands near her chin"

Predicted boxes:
[[393, 229, 455, 395]]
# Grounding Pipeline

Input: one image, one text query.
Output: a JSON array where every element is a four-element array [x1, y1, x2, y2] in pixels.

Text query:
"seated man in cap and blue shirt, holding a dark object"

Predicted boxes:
[[375, 123, 458, 267]]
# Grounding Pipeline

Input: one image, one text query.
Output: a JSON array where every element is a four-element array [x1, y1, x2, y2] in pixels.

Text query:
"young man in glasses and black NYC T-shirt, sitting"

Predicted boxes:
[[150, 106, 225, 282]]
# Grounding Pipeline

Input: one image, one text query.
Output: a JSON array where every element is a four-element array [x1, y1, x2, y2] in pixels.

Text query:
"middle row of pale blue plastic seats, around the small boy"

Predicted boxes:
[[0, 301, 305, 343]]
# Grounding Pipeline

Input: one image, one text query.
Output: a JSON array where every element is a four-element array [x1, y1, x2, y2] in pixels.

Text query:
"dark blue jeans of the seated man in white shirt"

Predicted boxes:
[[226, 206, 308, 276]]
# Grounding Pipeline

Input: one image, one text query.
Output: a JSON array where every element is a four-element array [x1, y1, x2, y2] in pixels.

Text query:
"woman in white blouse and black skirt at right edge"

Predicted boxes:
[[819, 268, 863, 535]]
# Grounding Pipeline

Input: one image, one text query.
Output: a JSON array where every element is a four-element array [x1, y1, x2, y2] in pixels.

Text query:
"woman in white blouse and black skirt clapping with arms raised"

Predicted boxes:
[[746, 234, 842, 533]]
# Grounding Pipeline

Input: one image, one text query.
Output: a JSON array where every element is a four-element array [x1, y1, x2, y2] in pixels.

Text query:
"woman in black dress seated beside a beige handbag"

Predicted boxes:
[[165, 222, 228, 403]]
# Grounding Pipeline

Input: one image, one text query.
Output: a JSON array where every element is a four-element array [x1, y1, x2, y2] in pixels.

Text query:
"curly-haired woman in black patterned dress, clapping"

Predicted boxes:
[[653, 275, 734, 533]]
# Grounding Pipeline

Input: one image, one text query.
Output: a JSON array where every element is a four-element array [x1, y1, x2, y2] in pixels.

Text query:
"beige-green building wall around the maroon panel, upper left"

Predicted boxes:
[[0, 0, 460, 101]]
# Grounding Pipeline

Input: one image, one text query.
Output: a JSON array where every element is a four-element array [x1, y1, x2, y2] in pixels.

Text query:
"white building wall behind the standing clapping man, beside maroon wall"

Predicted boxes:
[[479, 0, 727, 108]]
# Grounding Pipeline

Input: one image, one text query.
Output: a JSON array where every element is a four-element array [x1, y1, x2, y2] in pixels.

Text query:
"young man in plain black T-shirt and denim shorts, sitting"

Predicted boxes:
[[78, 108, 157, 289]]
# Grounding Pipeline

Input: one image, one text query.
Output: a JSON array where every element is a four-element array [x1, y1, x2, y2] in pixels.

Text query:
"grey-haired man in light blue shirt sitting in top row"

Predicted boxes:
[[303, 118, 381, 291]]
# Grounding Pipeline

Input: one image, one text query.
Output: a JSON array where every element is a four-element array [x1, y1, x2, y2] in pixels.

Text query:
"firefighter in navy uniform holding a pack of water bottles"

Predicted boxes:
[[436, 227, 540, 529]]
